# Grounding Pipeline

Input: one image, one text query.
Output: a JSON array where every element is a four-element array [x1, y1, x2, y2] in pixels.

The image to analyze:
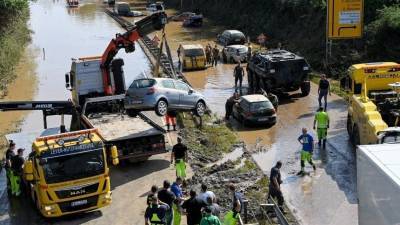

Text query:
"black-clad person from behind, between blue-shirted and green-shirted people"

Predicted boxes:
[[182, 190, 207, 225]]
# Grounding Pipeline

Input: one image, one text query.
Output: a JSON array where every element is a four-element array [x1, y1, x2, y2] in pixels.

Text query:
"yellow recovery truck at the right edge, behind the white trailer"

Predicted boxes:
[[341, 62, 400, 145]]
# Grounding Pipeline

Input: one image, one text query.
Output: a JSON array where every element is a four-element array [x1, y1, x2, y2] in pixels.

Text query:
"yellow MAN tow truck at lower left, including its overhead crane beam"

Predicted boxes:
[[0, 101, 119, 217]]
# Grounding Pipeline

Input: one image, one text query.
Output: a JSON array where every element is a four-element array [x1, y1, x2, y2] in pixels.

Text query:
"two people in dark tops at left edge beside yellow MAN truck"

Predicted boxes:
[[5, 140, 24, 196]]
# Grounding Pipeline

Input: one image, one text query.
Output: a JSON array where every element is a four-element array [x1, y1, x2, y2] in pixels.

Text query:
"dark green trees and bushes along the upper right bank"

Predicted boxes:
[[166, 0, 400, 75]]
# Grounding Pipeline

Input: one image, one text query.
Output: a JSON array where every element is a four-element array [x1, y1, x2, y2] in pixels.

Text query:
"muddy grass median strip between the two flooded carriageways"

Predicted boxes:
[[178, 114, 295, 222]]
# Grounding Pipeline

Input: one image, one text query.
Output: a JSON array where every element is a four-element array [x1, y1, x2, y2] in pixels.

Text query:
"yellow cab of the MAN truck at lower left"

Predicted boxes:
[[24, 130, 117, 217]]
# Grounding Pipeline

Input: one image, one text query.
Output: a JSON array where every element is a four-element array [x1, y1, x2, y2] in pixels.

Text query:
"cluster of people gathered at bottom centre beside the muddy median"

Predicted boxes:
[[145, 137, 243, 225]]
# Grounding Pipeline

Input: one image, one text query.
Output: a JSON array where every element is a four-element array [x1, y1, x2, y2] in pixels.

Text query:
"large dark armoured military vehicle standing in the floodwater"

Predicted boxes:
[[247, 50, 311, 96]]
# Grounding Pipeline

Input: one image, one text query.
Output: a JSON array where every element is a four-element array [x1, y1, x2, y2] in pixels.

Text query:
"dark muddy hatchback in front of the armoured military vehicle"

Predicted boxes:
[[233, 94, 276, 125]]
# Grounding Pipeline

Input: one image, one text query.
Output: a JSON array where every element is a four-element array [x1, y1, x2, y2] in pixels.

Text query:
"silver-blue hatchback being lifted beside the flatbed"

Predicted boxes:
[[124, 78, 206, 116]]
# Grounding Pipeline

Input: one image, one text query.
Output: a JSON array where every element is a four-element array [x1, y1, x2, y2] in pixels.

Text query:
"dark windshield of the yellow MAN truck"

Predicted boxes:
[[39, 148, 105, 184]]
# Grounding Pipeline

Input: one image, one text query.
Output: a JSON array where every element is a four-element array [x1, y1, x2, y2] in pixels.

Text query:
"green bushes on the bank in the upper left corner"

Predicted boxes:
[[0, 0, 30, 94]]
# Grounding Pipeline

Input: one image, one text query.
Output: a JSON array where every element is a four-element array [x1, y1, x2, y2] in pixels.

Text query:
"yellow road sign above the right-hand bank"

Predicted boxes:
[[327, 0, 364, 39]]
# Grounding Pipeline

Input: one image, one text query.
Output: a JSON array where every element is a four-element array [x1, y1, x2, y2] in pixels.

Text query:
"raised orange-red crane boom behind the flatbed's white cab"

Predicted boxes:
[[100, 11, 167, 95]]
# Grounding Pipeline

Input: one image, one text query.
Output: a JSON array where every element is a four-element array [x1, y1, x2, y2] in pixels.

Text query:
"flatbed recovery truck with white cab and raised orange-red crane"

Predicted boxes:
[[65, 12, 167, 162]]
